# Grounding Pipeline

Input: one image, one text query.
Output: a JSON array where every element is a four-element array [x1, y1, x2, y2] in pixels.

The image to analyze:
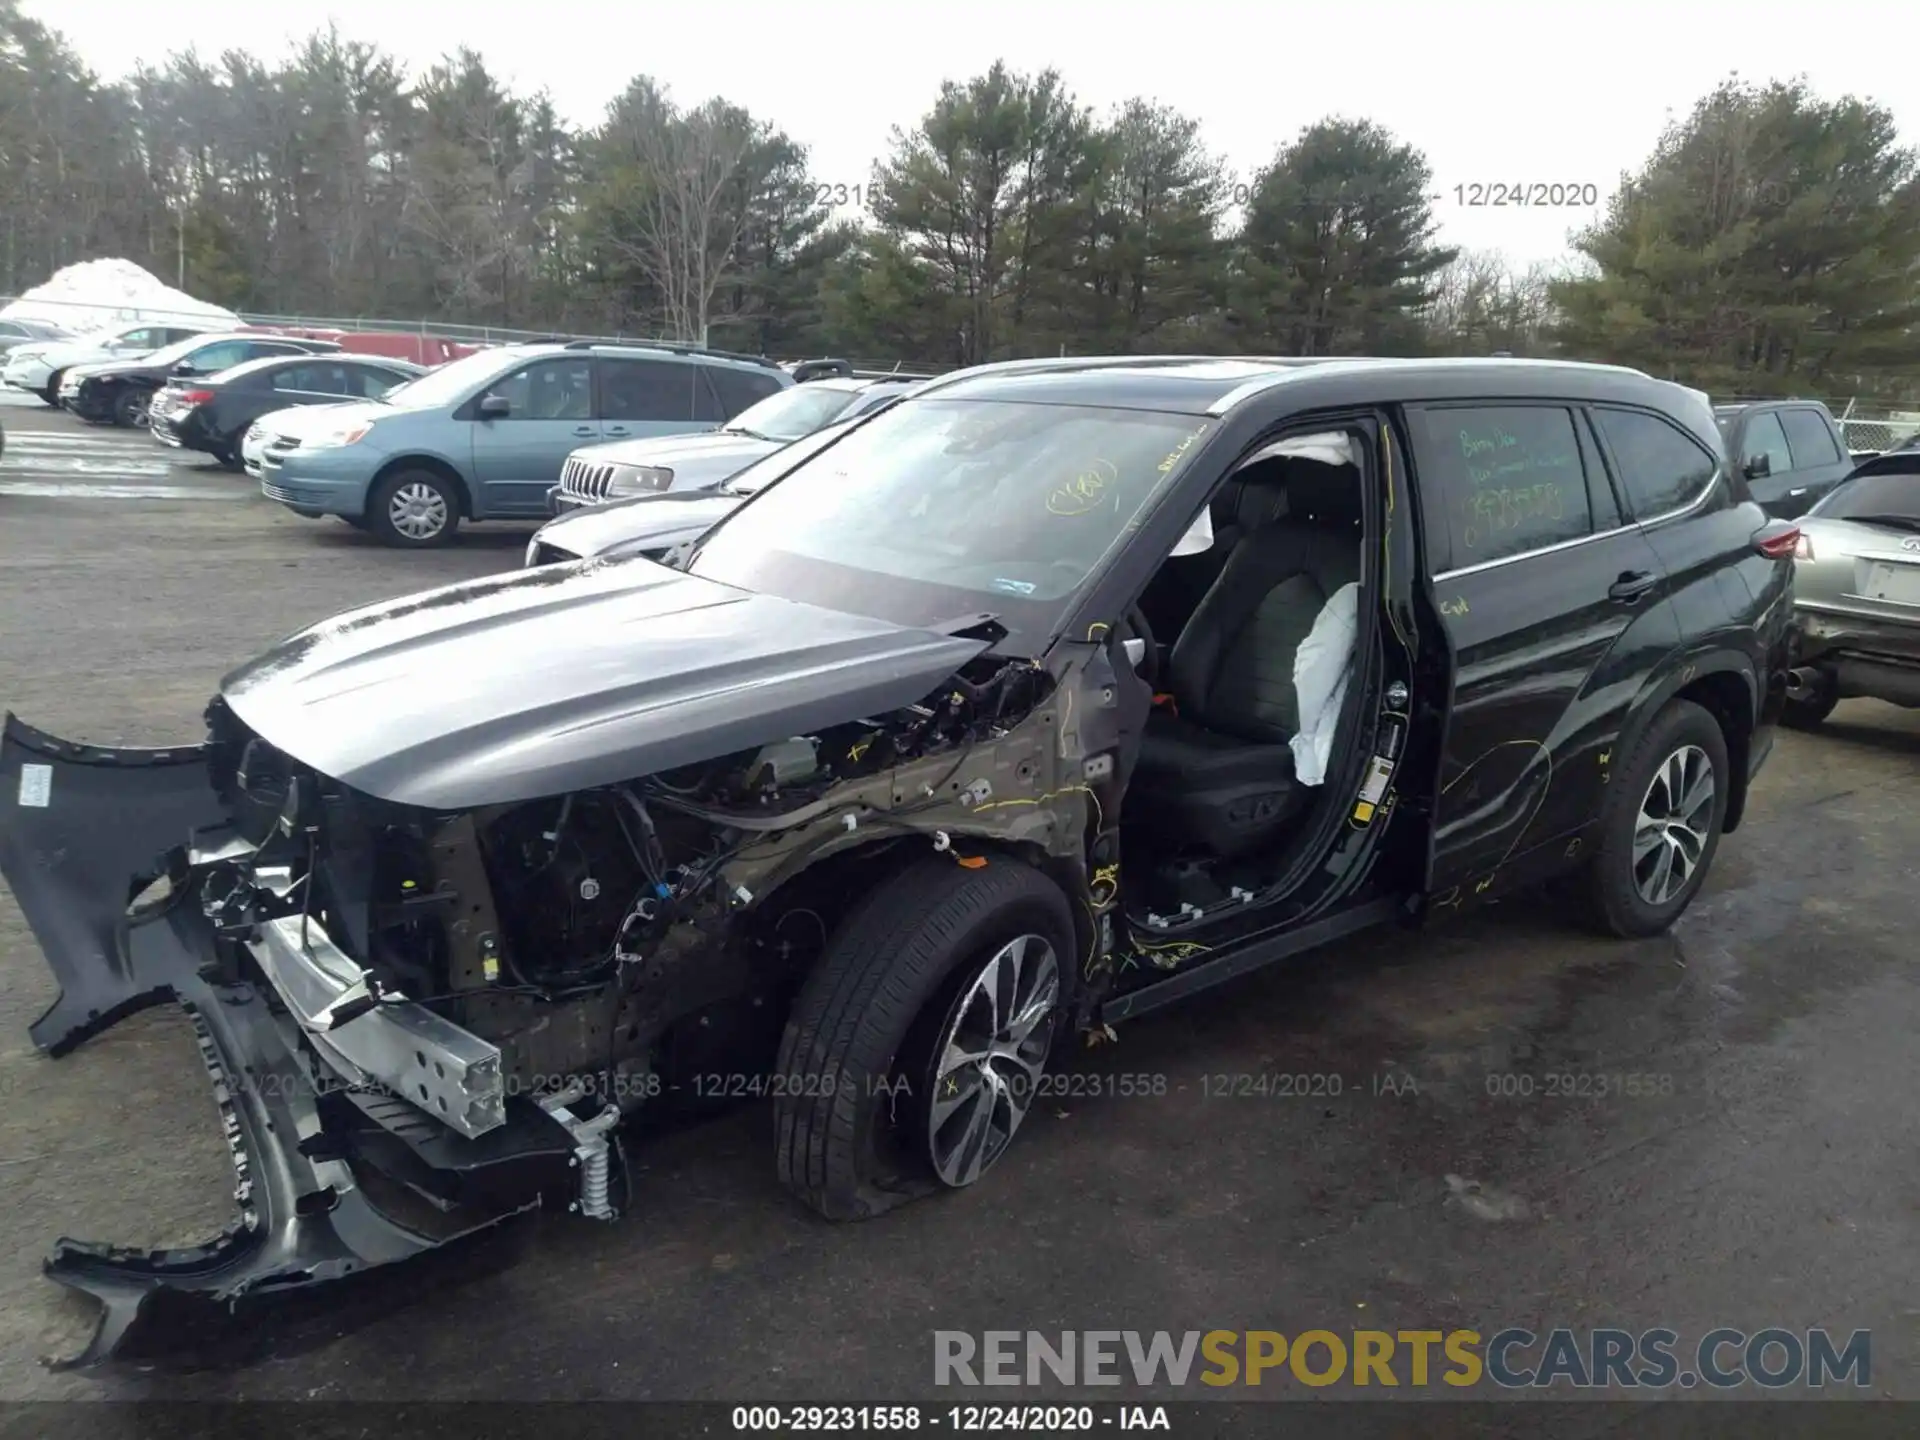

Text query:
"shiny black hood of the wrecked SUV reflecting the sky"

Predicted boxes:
[[221, 559, 987, 810]]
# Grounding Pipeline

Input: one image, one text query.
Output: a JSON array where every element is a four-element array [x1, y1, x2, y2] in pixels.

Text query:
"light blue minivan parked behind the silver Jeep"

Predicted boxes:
[[261, 340, 795, 549]]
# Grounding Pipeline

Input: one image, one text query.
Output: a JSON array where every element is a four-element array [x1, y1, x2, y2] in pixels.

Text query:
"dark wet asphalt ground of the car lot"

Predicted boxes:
[[0, 403, 1920, 1402]]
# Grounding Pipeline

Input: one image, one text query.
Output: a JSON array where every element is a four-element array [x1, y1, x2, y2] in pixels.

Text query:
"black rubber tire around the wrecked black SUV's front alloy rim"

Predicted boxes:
[[774, 856, 1075, 1219]]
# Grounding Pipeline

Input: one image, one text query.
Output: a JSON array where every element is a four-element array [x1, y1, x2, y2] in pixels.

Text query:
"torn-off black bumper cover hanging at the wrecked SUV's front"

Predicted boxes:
[[0, 716, 574, 1367]]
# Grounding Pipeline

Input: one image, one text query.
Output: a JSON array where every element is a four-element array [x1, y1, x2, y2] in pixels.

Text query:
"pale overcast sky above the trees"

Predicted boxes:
[[25, 0, 1920, 261]]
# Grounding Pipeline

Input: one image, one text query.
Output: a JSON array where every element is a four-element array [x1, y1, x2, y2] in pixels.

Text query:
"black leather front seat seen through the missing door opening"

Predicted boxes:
[[1125, 459, 1363, 860]]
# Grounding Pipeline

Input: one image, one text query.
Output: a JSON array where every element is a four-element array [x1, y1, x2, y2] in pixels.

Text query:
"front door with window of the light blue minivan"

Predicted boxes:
[[470, 355, 601, 520]]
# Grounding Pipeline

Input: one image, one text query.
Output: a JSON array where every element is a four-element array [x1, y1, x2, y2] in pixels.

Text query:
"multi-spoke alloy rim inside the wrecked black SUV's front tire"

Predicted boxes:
[[927, 935, 1060, 1187]]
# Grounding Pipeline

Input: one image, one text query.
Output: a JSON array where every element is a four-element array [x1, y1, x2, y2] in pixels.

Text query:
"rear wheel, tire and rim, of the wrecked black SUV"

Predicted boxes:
[[1586, 701, 1734, 939]]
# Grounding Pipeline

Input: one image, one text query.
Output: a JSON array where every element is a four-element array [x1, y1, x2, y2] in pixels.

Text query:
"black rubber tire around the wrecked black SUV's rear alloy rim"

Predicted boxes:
[[1582, 701, 1734, 939]]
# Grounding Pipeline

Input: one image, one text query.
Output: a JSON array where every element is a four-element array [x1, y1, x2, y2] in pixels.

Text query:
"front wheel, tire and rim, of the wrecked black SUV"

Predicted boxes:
[[774, 858, 1075, 1219]]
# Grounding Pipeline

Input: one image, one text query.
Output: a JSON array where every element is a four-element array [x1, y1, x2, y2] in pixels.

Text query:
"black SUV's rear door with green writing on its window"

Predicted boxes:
[[1409, 401, 1674, 906]]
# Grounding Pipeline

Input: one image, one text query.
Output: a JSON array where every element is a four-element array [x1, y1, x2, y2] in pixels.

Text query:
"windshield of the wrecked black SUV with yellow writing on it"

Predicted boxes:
[[689, 399, 1210, 655]]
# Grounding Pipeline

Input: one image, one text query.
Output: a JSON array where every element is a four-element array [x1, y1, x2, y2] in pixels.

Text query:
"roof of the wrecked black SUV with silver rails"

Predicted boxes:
[[916, 355, 1676, 415]]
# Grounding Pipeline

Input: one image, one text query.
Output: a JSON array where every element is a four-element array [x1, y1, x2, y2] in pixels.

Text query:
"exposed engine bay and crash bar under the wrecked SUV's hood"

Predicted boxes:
[[187, 660, 1048, 1167]]
